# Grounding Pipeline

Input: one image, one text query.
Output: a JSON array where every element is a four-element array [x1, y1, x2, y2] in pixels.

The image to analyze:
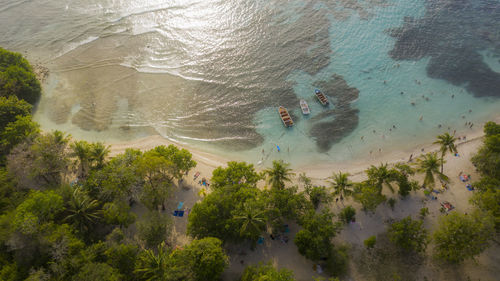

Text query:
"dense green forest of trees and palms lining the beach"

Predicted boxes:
[[0, 49, 500, 281]]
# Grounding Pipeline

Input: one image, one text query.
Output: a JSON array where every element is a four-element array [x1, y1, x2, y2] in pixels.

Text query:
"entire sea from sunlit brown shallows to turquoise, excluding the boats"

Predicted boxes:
[[0, 0, 500, 166]]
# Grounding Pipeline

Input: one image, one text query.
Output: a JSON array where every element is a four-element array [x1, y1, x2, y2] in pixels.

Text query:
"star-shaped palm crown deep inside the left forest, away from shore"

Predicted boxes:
[[65, 187, 102, 234]]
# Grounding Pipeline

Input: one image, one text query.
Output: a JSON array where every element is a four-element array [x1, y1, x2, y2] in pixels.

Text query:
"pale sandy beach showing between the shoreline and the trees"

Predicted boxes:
[[111, 115, 500, 280]]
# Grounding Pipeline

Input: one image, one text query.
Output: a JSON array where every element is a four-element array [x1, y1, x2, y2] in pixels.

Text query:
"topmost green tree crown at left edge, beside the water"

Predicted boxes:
[[0, 48, 42, 104]]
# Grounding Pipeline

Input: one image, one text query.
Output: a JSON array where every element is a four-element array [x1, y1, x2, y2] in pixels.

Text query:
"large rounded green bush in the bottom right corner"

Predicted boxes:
[[433, 211, 495, 263]]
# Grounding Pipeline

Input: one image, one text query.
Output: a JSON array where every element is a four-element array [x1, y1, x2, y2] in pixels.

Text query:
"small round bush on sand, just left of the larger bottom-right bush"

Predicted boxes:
[[387, 216, 429, 253]]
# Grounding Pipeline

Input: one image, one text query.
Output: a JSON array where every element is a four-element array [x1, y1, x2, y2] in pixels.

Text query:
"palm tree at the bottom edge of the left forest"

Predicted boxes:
[[134, 242, 168, 281]]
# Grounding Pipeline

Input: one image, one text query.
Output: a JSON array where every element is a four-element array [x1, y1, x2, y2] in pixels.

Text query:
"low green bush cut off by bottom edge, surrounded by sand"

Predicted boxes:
[[240, 262, 295, 281]]
